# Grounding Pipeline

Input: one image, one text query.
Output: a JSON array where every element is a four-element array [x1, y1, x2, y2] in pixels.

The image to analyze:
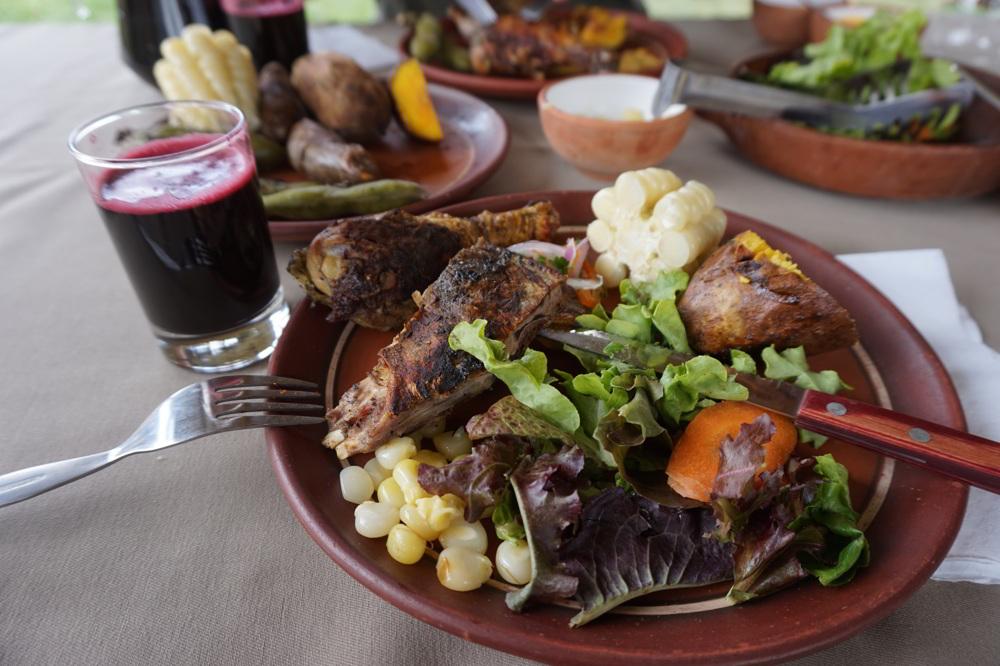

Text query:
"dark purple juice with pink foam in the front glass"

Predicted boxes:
[[97, 134, 279, 336]]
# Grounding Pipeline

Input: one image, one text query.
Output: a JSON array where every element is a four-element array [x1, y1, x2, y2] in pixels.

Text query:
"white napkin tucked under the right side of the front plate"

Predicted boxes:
[[837, 249, 1000, 585]]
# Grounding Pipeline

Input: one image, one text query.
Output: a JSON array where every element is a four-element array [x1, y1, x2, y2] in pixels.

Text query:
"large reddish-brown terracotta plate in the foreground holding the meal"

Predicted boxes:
[[267, 192, 968, 666]]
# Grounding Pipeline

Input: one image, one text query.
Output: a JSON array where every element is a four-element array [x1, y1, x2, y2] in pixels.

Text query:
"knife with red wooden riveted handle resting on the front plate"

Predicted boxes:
[[541, 329, 1000, 493]]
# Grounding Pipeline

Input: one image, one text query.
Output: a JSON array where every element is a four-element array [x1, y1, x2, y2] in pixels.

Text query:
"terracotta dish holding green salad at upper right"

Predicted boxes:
[[699, 51, 1000, 199]]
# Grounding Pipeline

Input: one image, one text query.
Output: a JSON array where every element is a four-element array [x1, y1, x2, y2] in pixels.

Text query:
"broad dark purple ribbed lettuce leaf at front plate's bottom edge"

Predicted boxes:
[[560, 487, 733, 627]]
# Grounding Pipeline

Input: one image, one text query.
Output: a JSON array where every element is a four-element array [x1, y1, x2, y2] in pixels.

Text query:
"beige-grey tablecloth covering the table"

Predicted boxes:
[[0, 22, 1000, 666]]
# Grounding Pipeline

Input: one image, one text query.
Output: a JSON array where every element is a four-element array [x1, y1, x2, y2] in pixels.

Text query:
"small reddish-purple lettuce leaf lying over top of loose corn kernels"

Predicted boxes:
[[417, 434, 528, 522]]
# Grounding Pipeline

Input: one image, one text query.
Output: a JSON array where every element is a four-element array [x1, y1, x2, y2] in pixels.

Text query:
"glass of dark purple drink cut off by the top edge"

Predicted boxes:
[[220, 0, 309, 69]]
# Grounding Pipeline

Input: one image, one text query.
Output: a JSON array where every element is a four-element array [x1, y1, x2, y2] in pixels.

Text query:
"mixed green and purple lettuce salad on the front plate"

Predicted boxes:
[[418, 271, 870, 626]]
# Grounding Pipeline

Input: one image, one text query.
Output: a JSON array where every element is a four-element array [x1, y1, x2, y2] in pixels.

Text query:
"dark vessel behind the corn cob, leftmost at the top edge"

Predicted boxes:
[[118, 0, 228, 86]]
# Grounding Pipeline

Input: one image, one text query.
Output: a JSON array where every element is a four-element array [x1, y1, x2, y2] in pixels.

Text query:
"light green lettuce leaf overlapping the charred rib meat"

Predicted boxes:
[[448, 319, 580, 433]]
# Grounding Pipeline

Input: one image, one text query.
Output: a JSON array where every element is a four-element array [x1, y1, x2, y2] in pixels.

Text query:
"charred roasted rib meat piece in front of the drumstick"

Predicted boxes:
[[323, 241, 576, 458]]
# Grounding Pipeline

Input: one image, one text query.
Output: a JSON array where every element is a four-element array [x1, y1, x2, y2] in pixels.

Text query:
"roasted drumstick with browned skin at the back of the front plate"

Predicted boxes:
[[288, 201, 559, 329]]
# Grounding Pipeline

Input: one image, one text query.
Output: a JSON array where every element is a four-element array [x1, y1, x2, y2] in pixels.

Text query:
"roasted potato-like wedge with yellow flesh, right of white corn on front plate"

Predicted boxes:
[[677, 231, 858, 354]]
